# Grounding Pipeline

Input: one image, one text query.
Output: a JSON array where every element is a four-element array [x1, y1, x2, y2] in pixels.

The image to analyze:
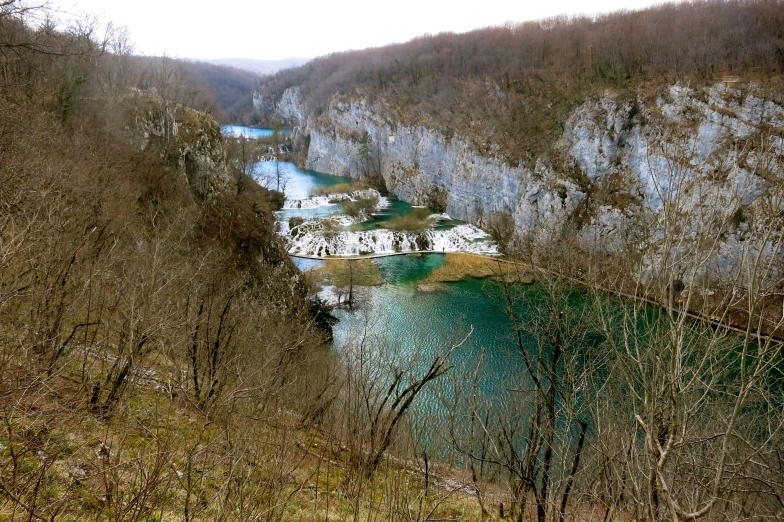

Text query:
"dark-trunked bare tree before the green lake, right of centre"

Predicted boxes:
[[449, 271, 601, 521]]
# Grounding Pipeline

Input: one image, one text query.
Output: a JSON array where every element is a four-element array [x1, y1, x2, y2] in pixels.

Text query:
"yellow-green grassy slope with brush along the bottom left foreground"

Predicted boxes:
[[0, 356, 496, 522]]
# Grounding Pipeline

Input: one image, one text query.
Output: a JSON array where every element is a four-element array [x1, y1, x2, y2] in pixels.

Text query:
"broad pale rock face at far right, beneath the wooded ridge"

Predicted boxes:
[[559, 84, 784, 267]]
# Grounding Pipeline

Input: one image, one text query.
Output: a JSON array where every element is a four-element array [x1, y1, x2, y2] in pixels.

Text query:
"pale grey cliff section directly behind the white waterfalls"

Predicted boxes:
[[307, 97, 584, 242]]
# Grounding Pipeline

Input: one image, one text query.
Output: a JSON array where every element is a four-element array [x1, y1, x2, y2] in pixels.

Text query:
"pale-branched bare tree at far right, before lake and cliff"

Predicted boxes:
[[594, 129, 784, 522]]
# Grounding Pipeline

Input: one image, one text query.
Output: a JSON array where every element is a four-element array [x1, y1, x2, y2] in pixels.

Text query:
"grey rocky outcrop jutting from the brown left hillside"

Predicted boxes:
[[132, 97, 231, 198]]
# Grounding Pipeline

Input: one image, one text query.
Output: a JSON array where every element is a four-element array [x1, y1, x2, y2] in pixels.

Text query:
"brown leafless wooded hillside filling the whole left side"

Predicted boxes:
[[0, 1, 330, 520]]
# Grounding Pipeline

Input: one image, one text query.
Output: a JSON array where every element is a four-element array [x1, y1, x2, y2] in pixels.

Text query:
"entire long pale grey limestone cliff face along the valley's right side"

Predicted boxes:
[[268, 83, 784, 278]]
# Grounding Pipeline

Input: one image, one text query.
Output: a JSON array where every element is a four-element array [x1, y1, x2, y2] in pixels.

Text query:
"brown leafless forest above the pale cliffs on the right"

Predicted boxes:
[[260, 0, 784, 164]]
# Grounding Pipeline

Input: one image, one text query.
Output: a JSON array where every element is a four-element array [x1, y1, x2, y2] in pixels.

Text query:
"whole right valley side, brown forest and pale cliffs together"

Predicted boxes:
[[254, 1, 784, 288]]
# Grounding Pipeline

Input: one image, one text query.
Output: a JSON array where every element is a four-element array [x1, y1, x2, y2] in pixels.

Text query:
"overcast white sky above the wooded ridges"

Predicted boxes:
[[50, 0, 662, 60]]
